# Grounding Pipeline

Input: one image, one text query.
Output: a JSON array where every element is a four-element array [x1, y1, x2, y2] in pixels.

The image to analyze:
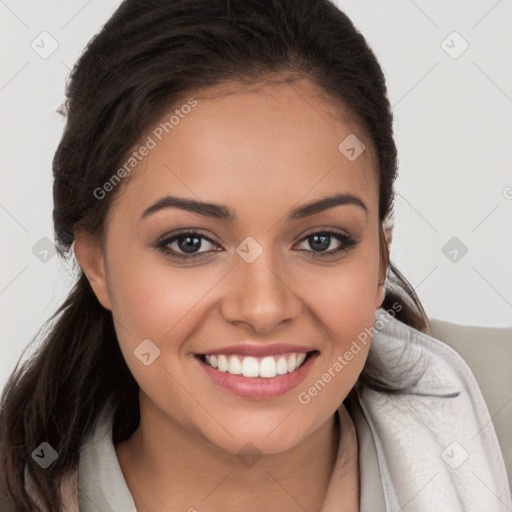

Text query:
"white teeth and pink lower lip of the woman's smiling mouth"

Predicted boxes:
[[195, 350, 319, 399]]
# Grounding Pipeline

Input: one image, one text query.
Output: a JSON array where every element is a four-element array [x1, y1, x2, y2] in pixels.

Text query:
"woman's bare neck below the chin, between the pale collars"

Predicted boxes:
[[115, 400, 358, 512]]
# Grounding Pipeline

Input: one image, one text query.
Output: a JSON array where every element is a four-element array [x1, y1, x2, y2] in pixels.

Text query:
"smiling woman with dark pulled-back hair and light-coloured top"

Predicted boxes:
[[0, 0, 510, 512]]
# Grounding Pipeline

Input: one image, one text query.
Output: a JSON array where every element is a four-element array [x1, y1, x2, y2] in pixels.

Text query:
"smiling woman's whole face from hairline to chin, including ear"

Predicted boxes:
[[75, 80, 386, 453]]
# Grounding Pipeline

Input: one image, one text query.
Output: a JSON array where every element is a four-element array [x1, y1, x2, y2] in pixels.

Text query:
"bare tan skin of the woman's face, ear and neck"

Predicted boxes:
[[74, 79, 386, 512]]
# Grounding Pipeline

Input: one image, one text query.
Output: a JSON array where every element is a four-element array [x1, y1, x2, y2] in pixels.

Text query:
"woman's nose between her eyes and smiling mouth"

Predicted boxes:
[[222, 251, 302, 334]]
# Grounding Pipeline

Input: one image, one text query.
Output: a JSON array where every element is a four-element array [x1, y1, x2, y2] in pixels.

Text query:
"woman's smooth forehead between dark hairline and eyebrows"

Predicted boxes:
[[111, 79, 377, 223]]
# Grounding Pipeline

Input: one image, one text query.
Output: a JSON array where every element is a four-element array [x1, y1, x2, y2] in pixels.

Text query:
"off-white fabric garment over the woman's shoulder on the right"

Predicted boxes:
[[356, 310, 512, 510]]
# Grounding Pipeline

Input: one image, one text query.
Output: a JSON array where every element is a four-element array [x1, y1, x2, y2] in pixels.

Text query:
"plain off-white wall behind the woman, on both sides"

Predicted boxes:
[[0, 0, 512, 388]]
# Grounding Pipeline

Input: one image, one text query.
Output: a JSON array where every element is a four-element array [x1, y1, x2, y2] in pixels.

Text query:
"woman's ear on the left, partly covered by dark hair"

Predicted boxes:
[[73, 230, 112, 310]]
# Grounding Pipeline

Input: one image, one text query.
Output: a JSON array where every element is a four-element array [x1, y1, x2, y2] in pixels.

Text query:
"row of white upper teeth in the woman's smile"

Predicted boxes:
[[204, 353, 306, 379]]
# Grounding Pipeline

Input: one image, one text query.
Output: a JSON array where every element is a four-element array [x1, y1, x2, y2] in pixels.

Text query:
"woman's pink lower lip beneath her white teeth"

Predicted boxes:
[[195, 352, 318, 400]]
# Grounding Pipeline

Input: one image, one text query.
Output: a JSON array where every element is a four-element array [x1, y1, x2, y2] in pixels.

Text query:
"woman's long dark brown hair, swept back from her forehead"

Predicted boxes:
[[0, 0, 428, 512]]
